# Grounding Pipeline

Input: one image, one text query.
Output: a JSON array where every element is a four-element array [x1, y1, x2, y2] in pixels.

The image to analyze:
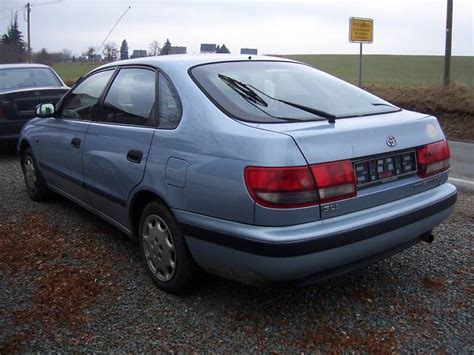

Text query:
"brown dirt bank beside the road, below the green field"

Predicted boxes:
[[365, 85, 474, 140]]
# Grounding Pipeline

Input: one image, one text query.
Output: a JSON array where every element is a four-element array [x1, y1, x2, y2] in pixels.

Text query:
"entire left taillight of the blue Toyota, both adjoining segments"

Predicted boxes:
[[244, 160, 357, 208]]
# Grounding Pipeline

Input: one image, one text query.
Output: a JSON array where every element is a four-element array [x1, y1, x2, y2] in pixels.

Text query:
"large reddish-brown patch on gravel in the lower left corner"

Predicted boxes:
[[0, 214, 124, 353]]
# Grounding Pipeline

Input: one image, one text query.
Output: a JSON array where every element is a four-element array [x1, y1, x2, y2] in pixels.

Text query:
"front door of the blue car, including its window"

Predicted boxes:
[[35, 69, 114, 202]]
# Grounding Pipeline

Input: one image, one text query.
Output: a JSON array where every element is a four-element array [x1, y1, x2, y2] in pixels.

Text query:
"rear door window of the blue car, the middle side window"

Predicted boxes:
[[99, 68, 156, 126]]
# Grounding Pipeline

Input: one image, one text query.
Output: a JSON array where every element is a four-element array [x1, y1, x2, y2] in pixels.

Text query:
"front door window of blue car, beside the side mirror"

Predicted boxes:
[[62, 70, 114, 120]]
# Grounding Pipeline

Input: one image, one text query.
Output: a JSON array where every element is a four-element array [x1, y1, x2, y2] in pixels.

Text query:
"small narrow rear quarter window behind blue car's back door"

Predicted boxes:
[[158, 73, 181, 129]]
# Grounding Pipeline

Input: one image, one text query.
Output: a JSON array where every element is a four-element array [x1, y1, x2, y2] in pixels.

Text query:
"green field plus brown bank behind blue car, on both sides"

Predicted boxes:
[[53, 55, 474, 141]]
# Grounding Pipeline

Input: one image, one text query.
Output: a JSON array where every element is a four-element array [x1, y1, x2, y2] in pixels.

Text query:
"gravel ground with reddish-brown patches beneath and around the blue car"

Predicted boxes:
[[0, 143, 474, 353]]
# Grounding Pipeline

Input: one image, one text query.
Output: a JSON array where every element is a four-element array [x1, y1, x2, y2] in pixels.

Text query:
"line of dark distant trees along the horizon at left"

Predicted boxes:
[[0, 16, 230, 64]]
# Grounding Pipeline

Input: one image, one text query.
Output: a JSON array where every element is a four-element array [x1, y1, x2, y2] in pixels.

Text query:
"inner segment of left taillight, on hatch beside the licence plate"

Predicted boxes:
[[311, 160, 357, 203]]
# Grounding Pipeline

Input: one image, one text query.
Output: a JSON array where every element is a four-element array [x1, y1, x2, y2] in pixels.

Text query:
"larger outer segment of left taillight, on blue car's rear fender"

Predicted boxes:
[[244, 166, 318, 208]]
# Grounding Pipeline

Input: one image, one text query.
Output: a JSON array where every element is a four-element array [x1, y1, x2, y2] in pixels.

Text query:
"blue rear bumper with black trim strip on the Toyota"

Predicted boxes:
[[174, 184, 457, 284]]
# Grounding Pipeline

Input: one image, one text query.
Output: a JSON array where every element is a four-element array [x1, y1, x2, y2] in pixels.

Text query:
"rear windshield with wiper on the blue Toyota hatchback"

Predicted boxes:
[[191, 60, 400, 123]]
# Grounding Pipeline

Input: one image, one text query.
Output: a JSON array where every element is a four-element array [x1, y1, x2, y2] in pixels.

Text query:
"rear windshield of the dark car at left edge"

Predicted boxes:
[[0, 68, 62, 92]]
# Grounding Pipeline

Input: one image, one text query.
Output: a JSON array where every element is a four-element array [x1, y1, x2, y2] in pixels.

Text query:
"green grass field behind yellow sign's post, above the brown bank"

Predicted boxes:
[[284, 54, 474, 87]]
